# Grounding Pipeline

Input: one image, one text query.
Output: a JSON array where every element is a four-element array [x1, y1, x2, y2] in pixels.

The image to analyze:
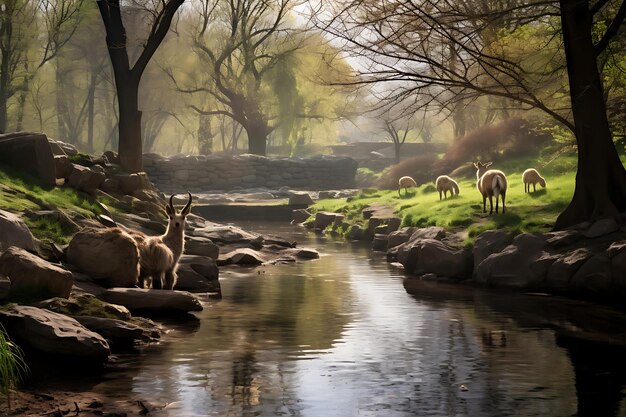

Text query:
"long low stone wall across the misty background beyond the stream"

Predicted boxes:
[[143, 154, 357, 192]]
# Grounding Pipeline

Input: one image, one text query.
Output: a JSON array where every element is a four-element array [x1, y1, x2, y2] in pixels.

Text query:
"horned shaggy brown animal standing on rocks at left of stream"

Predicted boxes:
[[133, 192, 192, 290]]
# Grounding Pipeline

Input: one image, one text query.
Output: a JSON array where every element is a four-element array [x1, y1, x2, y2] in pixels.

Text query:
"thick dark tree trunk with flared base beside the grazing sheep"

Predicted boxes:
[[555, 0, 626, 230]]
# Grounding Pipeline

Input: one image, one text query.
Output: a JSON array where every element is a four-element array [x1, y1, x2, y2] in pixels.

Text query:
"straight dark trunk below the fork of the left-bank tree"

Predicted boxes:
[[115, 79, 143, 173]]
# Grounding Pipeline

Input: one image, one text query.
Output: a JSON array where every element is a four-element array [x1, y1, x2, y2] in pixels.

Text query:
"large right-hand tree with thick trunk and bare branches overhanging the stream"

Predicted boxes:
[[318, 0, 626, 229]]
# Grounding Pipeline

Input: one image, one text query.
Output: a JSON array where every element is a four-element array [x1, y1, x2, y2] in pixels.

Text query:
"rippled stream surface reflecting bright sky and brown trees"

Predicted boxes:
[[46, 225, 626, 417]]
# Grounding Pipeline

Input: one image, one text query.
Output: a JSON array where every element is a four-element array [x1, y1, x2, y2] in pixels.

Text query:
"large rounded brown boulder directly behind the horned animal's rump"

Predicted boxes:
[[67, 227, 139, 287]]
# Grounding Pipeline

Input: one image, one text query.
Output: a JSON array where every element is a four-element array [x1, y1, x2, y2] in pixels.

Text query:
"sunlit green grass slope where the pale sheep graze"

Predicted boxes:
[[312, 157, 576, 243]]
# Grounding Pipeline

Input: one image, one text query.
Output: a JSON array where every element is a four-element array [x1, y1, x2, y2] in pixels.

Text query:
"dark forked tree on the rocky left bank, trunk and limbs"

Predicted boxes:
[[97, 0, 184, 172]]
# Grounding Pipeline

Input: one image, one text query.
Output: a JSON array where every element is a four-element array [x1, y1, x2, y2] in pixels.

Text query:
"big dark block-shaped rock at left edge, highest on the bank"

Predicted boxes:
[[0, 132, 56, 186]]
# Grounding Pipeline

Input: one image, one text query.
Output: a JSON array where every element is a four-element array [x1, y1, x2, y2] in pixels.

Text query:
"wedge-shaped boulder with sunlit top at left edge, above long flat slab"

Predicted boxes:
[[0, 246, 74, 300]]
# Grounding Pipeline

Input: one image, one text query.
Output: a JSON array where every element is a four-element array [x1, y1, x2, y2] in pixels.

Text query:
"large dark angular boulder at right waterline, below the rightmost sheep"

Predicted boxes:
[[474, 233, 556, 288]]
